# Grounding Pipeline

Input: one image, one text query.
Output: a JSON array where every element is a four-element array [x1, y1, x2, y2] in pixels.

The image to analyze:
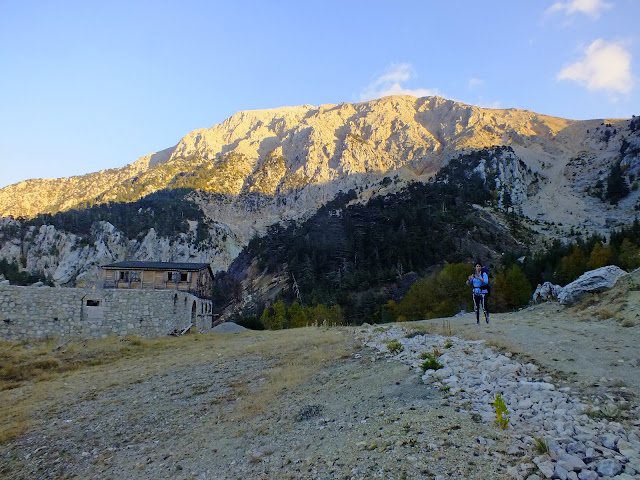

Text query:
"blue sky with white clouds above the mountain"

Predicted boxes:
[[0, 0, 640, 187]]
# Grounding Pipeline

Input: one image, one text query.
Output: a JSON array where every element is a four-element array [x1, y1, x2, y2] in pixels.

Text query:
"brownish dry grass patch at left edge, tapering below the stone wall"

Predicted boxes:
[[0, 335, 229, 444]]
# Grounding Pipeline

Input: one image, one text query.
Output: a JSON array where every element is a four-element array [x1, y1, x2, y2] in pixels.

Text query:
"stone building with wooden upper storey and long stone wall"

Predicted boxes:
[[0, 262, 218, 340]]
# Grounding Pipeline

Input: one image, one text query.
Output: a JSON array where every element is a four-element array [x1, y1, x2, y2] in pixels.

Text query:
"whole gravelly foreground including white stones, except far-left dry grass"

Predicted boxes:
[[0, 292, 640, 480]]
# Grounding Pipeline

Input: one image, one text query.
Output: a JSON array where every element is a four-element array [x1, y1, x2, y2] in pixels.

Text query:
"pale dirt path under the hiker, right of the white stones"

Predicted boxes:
[[438, 300, 640, 403]]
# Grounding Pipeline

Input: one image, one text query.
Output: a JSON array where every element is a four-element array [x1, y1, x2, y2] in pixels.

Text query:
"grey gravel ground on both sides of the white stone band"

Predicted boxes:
[[0, 296, 640, 480]]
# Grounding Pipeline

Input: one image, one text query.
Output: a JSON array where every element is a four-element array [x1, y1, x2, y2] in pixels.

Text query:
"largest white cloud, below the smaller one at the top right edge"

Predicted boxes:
[[557, 39, 633, 94]]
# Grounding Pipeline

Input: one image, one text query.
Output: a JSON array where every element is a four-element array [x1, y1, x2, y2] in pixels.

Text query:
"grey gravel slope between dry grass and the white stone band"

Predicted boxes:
[[0, 329, 507, 479]]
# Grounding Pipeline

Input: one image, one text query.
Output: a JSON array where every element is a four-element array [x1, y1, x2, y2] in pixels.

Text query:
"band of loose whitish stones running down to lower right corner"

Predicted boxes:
[[359, 327, 640, 480]]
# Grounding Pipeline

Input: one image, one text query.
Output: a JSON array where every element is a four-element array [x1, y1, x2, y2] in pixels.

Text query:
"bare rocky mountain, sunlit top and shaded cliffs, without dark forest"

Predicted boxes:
[[0, 96, 640, 284]]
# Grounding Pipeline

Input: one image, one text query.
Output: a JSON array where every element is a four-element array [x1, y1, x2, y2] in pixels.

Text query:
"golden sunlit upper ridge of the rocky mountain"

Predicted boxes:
[[0, 96, 608, 217]]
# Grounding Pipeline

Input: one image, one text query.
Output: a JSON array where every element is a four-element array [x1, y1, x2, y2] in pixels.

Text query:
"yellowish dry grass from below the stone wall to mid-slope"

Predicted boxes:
[[0, 327, 354, 444]]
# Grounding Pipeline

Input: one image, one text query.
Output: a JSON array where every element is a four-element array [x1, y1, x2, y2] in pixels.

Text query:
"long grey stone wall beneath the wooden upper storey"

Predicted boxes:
[[0, 285, 213, 340]]
